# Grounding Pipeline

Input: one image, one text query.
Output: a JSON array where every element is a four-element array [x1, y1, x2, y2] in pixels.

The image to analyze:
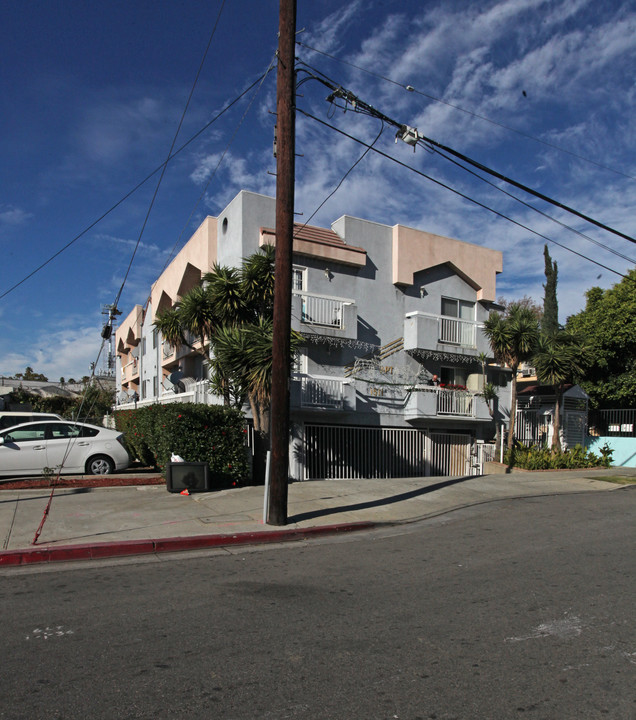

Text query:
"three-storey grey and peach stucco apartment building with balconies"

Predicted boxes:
[[116, 191, 510, 480]]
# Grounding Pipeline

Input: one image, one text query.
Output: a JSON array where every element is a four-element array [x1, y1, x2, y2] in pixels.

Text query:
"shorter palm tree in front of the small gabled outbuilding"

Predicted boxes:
[[533, 330, 589, 452]]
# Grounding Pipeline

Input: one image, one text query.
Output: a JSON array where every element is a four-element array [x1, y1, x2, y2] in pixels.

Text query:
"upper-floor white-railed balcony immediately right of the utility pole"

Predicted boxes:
[[292, 291, 358, 340]]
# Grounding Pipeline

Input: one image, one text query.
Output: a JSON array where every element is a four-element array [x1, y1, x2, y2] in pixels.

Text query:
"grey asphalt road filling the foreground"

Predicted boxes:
[[0, 488, 636, 720]]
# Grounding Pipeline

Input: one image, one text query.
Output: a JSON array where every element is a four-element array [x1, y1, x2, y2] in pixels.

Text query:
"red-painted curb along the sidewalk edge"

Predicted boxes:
[[0, 522, 377, 567]]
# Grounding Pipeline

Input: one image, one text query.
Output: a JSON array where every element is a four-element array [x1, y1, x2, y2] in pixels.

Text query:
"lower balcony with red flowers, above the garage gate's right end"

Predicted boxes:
[[404, 387, 490, 422]]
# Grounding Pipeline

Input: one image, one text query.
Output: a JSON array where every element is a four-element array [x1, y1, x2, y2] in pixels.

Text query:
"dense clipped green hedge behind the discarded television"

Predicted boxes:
[[115, 403, 249, 487]]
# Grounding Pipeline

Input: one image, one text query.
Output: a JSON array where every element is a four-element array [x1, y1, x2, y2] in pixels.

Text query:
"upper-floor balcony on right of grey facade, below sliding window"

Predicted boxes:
[[404, 312, 490, 357]]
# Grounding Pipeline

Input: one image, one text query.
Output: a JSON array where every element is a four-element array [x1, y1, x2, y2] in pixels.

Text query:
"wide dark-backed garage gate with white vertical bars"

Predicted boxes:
[[304, 425, 427, 480]]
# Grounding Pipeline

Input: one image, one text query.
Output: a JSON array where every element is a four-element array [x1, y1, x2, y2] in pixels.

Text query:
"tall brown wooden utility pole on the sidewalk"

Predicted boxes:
[[267, 0, 296, 525]]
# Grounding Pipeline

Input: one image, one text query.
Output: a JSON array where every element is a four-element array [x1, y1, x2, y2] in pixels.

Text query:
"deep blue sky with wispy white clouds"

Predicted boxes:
[[0, 0, 636, 380]]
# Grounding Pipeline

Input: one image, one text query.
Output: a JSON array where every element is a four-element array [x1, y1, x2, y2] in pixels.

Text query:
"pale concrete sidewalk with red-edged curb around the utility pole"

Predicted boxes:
[[0, 468, 636, 566]]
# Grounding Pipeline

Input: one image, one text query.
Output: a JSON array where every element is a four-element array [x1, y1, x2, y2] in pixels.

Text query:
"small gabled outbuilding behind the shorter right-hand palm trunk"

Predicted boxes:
[[515, 385, 589, 448]]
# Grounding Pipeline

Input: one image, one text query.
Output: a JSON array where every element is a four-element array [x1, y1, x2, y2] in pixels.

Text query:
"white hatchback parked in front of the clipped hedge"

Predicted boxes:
[[0, 420, 130, 477]]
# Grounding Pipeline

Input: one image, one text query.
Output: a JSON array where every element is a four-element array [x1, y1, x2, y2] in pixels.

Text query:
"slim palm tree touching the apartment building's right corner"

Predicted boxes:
[[484, 303, 539, 449]]
